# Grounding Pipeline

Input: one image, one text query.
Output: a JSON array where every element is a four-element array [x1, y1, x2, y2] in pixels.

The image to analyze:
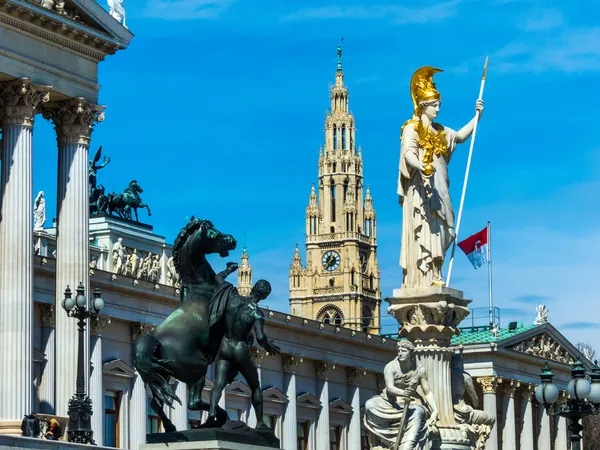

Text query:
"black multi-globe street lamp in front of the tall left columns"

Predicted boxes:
[[62, 283, 104, 445]]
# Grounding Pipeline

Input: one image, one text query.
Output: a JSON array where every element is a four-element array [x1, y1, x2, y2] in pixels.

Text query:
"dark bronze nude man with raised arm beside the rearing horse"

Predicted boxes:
[[207, 263, 279, 430]]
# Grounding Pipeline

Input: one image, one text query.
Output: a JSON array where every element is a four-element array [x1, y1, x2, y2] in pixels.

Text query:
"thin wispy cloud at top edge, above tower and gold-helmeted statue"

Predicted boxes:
[[283, 0, 463, 25]]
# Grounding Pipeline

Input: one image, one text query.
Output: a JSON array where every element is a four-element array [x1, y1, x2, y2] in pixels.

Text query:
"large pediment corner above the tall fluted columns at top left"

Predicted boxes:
[[0, 0, 133, 59]]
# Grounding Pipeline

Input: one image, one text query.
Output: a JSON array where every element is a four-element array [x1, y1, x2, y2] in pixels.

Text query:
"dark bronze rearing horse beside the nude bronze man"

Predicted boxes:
[[133, 217, 236, 432]]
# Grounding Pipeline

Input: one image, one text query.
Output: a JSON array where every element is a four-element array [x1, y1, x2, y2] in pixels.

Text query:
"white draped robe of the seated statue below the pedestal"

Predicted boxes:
[[363, 359, 433, 450]]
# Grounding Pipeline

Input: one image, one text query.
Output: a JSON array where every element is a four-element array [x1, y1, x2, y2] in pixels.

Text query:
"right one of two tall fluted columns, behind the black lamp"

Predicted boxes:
[[44, 98, 104, 416]]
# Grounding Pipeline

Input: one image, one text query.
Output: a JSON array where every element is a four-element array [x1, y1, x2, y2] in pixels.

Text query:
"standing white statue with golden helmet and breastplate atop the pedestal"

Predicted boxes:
[[398, 66, 483, 287]]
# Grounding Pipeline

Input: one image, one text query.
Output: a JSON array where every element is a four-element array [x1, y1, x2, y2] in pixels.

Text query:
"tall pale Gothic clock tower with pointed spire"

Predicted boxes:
[[290, 46, 381, 333]]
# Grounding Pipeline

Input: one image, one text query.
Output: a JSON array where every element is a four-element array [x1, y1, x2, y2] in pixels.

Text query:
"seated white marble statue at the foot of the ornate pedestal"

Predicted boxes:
[[363, 340, 438, 450]]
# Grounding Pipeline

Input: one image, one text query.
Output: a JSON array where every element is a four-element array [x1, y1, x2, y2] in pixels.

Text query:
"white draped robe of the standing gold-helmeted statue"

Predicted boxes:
[[398, 123, 456, 287]]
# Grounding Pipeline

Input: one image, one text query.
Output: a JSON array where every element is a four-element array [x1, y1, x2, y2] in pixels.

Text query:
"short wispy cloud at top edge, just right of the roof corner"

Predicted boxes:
[[144, 0, 235, 20]]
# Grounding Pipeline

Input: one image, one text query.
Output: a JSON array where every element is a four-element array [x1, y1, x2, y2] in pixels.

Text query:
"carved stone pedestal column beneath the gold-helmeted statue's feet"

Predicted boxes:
[[386, 286, 474, 450]]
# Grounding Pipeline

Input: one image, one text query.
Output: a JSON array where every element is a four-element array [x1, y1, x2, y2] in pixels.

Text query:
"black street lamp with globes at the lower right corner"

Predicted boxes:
[[535, 359, 600, 450]]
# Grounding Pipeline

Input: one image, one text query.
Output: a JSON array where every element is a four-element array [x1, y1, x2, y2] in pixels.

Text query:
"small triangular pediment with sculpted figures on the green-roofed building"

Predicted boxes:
[[506, 324, 580, 364]]
